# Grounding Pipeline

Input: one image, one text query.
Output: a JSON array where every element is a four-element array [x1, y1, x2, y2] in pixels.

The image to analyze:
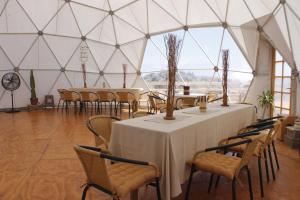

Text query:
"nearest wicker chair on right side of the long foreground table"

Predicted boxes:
[[185, 139, 257, 200]]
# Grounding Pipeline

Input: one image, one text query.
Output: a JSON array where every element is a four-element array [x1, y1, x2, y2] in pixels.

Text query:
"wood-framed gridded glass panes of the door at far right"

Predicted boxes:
[[272, 50, 291, 116]]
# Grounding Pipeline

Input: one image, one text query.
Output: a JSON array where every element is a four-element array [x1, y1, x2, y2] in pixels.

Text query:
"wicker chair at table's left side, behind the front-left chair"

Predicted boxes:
[[86, 115, 120, 149]]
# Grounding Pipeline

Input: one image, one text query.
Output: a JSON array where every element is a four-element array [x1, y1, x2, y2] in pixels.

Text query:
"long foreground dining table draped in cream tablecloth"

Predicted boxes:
[[110, 104, 256, 200]]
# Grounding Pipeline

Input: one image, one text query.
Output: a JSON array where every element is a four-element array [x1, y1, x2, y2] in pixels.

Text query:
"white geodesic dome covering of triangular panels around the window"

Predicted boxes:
[[0, 0, 300, 107]]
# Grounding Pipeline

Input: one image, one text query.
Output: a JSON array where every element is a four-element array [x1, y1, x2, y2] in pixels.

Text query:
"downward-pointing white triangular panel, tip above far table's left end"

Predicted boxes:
[[44, 35, 81, 66]]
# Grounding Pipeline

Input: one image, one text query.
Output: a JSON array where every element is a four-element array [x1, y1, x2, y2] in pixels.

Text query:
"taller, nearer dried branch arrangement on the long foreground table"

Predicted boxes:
[[164, 34, 181, 120]]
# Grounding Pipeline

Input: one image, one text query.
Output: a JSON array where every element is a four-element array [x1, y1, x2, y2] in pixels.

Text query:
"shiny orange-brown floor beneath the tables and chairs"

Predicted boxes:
[[0, 109, 300, 200]]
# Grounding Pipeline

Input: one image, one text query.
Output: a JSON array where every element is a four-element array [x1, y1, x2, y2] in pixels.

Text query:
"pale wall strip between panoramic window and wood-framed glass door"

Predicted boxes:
[[245, 37, 272, 118]]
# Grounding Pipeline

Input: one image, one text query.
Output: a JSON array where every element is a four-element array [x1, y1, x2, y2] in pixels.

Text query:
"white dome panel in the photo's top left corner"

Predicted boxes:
[[0, 0, 37, 33]]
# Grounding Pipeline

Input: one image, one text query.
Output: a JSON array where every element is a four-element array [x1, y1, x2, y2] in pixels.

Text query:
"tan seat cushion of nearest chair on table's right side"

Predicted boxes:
[[193, 153, 241, 180]]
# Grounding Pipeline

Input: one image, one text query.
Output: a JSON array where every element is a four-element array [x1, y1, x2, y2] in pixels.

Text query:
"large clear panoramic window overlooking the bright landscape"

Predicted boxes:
[[141, 27, 253, 102]]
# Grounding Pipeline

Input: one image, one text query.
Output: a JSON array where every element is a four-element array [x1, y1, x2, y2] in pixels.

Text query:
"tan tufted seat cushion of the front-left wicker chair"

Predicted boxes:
[[108, 163, 158, 197]]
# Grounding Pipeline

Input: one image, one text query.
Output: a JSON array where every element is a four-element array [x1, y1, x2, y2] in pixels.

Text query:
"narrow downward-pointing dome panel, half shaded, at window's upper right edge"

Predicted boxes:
[[230, 27, 259, 68]]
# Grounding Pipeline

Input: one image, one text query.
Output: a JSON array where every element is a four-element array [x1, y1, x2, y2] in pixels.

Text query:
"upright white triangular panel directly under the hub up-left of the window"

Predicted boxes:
[[87, 16, 116, 45]]
